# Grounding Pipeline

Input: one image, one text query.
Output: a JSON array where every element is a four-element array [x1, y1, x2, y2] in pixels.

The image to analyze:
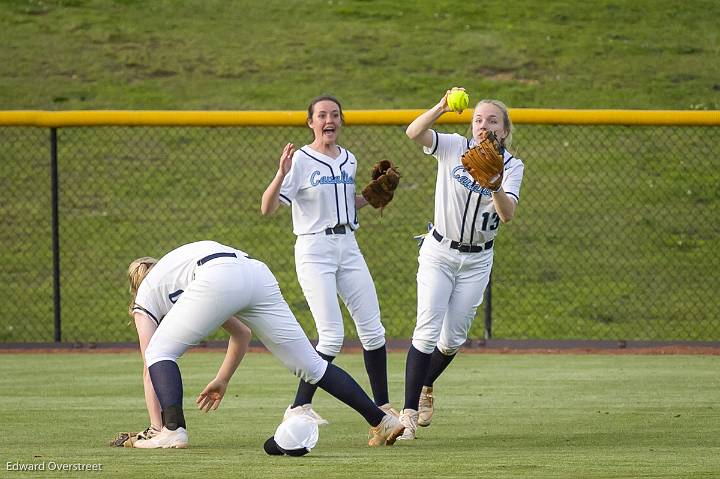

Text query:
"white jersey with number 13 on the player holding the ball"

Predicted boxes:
[[424, 130, 525, 245]]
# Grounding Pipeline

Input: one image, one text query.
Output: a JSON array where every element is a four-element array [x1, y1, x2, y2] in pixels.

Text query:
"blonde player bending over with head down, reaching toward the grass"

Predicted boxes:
[[128, 241, 404, 449]]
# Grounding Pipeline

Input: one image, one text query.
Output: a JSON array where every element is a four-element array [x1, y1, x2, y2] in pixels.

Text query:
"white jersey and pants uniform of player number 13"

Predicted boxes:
[[412, 130, 524, 355]]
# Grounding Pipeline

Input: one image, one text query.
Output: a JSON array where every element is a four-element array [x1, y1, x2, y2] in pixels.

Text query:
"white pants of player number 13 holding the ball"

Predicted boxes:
[[412, 235, 494, 355]]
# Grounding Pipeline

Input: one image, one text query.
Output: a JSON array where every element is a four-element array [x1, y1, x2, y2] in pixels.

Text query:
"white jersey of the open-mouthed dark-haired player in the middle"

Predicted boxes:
[[280, 145, 360, 235]]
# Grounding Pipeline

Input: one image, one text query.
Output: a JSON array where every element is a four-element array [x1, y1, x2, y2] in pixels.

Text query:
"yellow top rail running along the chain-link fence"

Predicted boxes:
[[0, 108, 720, 128]]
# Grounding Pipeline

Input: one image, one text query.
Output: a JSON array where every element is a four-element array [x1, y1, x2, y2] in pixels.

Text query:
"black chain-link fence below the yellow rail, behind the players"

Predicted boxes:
[[0, 118, 720, 343]]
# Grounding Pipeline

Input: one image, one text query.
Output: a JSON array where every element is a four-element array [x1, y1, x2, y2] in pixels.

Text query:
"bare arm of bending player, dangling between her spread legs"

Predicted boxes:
[[195, 316, 252, 412]]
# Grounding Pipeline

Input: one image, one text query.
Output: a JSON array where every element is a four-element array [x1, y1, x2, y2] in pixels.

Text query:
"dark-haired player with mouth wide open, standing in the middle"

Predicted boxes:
[[261, 96, 397, 424]]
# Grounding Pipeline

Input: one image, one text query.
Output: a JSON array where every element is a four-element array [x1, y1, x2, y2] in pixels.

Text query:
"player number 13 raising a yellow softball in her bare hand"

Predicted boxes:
[[400, 88, 524, 439]]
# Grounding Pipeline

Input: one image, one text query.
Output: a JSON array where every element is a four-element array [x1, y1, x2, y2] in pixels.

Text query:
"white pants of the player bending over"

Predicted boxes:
[[145, 257, 327, 384]]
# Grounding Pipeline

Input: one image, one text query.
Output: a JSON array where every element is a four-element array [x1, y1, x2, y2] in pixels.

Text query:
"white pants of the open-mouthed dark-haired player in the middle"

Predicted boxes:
[[295, 231, 385, 356]]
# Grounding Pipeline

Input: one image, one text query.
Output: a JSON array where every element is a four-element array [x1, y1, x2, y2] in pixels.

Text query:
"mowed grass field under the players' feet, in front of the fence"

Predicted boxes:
[[0, 352, 720, 478]]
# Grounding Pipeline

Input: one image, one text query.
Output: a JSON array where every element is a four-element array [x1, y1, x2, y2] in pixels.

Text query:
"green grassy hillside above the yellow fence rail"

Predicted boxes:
[[0, 0, 720, 110]]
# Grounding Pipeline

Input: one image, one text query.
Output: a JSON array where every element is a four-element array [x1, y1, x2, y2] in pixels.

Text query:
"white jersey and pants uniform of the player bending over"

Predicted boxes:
[[133, 241, 327, 384]]
